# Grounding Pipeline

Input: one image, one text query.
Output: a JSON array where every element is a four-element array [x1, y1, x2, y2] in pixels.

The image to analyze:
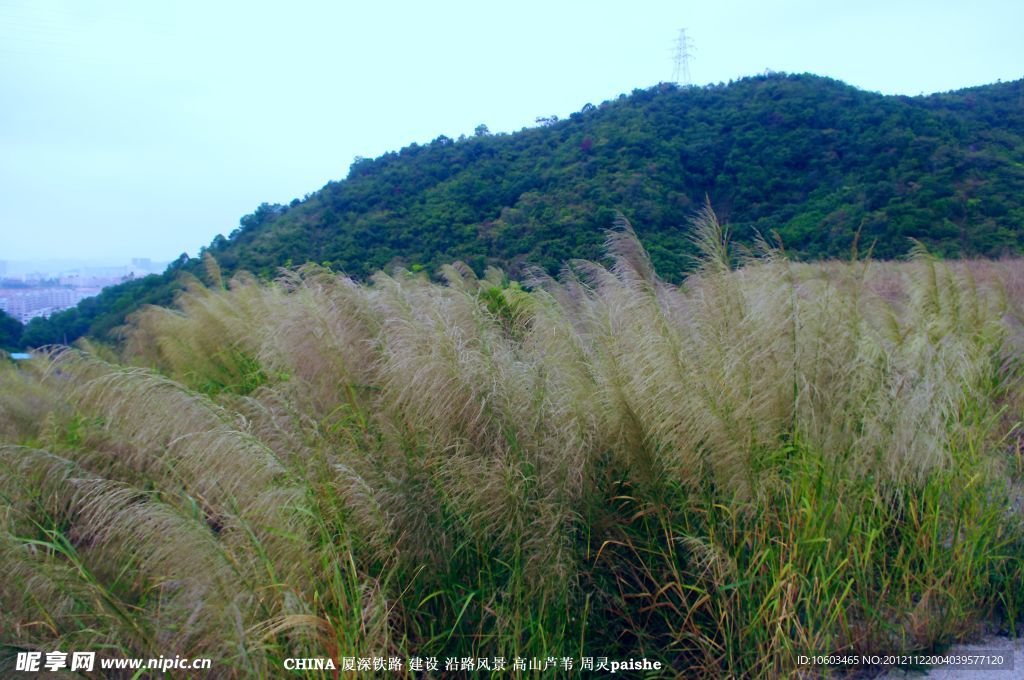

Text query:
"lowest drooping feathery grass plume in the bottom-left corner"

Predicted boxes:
[[0, 447, 237, 655]]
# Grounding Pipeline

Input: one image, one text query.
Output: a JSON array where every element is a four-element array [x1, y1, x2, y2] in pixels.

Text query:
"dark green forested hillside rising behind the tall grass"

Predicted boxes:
[[25, 75, 1024, 345]]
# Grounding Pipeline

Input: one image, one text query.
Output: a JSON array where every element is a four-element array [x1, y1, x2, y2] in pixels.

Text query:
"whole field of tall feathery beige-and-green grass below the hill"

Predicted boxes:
[[0, 211, 1024, 677]]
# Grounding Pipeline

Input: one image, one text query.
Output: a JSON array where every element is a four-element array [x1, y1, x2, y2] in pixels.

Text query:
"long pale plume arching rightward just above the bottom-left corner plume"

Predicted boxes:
[[39, 350, 311, 602]]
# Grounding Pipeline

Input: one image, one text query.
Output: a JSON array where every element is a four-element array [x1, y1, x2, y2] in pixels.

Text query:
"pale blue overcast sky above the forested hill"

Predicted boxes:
[[0, 0, 1024, 260]]
